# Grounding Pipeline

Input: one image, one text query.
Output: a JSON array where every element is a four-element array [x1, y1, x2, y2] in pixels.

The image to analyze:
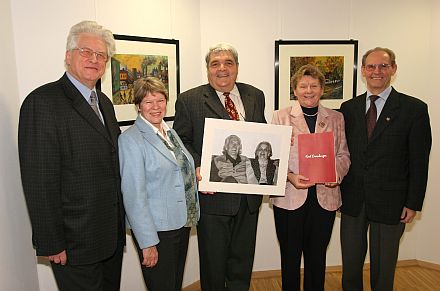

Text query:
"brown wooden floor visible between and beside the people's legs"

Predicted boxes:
[[183, 260, 440, 291]]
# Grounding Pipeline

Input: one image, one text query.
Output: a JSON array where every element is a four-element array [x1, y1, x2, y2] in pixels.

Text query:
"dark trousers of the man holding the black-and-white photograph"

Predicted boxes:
[[197, 195, 258, 291]]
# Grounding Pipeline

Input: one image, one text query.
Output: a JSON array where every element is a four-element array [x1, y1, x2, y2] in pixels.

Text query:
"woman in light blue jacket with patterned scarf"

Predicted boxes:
[[119, 77, 199, 291]]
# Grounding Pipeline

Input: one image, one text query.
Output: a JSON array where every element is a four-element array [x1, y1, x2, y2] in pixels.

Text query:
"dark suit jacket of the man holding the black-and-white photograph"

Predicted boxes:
[[173, 83, 266, 215]]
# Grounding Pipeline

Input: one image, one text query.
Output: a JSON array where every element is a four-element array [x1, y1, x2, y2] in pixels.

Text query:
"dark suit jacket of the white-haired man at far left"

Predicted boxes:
[[18, 74, 125, 265]]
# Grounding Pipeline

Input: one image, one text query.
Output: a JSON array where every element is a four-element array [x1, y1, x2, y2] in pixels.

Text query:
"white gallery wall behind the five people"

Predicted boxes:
[[0, 0, 440, 291]]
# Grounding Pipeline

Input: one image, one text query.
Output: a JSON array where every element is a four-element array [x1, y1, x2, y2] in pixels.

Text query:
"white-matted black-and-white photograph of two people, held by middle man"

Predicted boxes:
[[199, 118, 292, 196]]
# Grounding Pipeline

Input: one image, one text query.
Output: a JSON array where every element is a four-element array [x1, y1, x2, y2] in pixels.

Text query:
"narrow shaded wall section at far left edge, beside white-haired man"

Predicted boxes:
[[0, 0, 39, 291]]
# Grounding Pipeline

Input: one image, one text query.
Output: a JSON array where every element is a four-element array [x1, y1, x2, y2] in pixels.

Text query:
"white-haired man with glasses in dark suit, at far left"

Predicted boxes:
[[18, 21, 125, 291]]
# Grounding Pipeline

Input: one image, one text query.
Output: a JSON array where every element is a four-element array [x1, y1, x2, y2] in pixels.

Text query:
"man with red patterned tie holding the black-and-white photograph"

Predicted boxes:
[[173, 44, 266, 291]]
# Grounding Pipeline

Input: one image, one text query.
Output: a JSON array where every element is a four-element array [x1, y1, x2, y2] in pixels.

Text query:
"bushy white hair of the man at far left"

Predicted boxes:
[[66, 20, 116, 58]]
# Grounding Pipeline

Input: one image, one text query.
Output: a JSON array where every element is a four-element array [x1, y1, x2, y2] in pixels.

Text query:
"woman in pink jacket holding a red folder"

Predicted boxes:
[[271, 65, 350, 291]]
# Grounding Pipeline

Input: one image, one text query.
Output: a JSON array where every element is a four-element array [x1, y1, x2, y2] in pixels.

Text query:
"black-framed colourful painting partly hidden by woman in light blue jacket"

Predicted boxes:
[[101, 34, 180, 126]]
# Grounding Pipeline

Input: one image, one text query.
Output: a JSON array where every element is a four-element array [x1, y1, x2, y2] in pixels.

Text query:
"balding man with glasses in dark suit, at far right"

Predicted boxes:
[[341, 47, 431, 291]]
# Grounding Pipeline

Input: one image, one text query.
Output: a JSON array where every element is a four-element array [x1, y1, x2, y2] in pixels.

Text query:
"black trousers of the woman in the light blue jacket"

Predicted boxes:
[[132, 227, 191, 291]]
